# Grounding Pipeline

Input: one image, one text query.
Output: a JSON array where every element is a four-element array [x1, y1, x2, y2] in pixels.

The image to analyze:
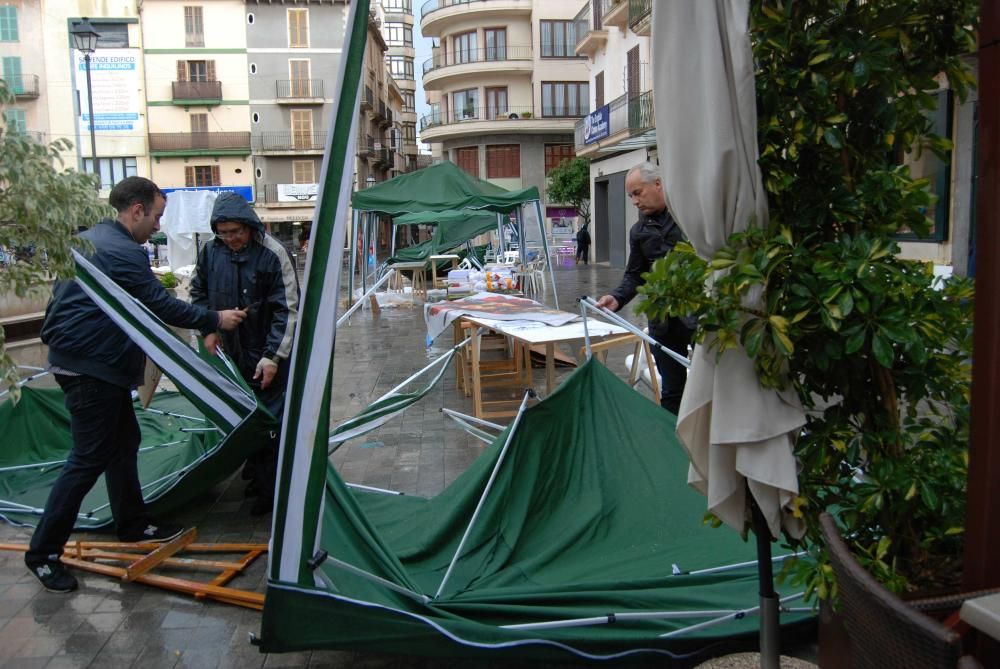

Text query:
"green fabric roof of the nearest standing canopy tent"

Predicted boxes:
[[351, 162, 539, 216]]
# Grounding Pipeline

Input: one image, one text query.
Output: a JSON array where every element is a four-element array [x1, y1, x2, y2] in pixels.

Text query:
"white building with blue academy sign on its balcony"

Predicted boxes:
[[574, 0, 656, 267]]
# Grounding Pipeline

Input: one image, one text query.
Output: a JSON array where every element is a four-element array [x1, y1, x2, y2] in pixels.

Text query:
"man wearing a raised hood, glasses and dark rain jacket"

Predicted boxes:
[[191, 193, 299, 515]]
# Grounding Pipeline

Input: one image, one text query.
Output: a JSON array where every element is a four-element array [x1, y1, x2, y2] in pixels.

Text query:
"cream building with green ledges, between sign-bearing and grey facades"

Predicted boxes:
[[142, 0, 253, 214]]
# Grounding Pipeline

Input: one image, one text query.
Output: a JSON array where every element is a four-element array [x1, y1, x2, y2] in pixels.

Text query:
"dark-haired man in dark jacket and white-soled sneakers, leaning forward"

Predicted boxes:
[[24, 177, 245, 592]]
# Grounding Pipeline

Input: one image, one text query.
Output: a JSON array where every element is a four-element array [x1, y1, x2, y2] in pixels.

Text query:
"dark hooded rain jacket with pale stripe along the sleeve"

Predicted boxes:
[[191, 193, 299, 381]]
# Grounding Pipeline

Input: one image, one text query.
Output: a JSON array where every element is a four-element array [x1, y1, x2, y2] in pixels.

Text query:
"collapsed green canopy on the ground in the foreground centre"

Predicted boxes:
[[262, 361, 806, 660]]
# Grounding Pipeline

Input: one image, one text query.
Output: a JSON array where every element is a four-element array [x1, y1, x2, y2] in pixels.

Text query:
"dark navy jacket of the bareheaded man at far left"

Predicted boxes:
[[42, 220, 219, 388]]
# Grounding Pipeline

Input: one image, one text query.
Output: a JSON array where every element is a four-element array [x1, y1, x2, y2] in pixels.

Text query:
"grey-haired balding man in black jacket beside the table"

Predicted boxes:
[[597, 162, 694, 415]]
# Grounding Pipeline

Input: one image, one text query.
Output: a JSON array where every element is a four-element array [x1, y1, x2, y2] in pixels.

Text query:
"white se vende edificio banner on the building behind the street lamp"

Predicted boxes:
[[74, 49, 142, 134]]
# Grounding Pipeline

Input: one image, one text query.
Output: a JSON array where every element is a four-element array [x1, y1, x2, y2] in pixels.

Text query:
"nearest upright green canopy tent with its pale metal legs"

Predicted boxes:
[[348, 161, 559, 307]]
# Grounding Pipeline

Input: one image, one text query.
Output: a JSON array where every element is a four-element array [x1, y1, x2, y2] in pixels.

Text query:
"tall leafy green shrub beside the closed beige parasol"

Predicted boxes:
[[640, 0, 978, 599]]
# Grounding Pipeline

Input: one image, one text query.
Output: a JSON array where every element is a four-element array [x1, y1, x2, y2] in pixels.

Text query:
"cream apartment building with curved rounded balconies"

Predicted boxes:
[[420, 0, 591, 239]]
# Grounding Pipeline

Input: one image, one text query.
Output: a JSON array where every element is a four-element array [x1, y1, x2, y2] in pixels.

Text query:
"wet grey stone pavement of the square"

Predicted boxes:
[[0, 264, 814, 669]]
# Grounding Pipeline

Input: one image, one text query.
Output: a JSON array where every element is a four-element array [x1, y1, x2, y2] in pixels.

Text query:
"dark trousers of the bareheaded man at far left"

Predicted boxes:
[[25, 374, 148, 561]]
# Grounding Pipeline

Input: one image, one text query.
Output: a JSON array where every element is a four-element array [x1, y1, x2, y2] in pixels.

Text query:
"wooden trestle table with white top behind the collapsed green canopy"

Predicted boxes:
[[462, 316, 628, 418]]
